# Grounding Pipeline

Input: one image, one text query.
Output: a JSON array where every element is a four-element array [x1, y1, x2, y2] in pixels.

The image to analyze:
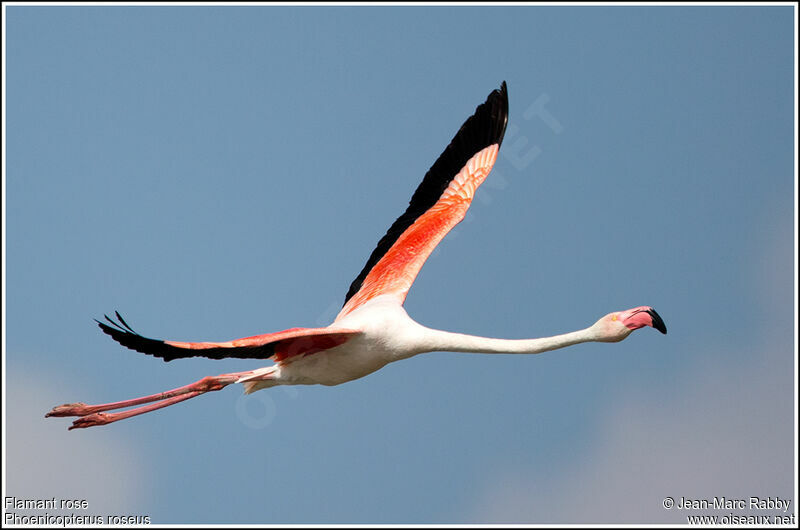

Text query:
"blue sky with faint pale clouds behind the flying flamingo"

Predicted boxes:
[[4, 6, 797, 523]]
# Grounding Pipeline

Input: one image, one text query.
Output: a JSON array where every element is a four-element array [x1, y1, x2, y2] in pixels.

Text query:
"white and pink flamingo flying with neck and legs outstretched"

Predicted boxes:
[[46, 81, 667, 430]]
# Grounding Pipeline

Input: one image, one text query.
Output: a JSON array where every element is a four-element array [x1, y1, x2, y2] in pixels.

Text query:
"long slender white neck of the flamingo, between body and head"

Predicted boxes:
[[422, 327, 597, 353]]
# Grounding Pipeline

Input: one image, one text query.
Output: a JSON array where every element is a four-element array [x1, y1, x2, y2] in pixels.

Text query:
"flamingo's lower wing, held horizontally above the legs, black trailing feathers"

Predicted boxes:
[[95, 313, 361, 362]]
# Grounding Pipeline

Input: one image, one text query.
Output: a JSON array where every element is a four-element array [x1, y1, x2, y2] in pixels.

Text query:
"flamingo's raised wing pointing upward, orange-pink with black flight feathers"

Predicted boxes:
[[339, 81, 508, 316]]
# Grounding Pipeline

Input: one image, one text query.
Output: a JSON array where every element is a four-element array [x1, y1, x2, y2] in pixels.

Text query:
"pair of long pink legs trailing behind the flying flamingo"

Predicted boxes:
[[45, 371, 252, 429]]
